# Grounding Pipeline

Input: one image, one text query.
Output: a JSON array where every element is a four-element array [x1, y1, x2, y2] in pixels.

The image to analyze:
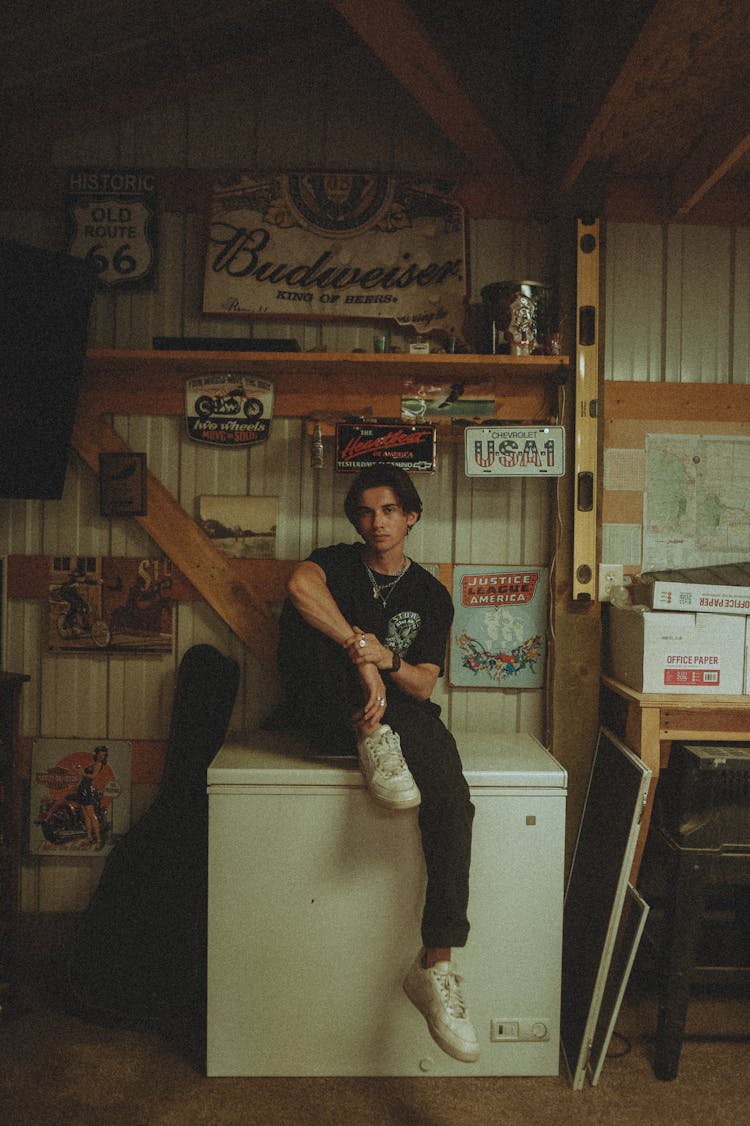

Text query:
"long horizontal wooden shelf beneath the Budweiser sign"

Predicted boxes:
[[81, 349, 569, 422]]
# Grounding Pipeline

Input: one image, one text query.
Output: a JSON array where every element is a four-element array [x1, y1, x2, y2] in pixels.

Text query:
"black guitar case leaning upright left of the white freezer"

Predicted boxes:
[[68, 645, 239, 1055]]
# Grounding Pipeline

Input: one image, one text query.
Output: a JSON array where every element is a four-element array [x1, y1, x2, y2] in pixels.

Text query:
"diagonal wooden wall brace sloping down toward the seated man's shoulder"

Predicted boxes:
[[72, 399, 278, 660]]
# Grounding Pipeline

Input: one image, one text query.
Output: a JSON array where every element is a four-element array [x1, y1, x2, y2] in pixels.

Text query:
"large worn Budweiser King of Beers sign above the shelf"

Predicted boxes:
[[203, 172, 466, 334]]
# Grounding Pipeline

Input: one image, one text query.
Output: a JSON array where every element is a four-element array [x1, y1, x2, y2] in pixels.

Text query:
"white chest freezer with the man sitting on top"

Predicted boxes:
[[207, 732, 566, 1075]]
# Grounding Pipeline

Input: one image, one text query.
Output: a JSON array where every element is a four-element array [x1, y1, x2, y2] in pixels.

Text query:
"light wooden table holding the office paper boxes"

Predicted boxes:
[[601, 677, 750, 884]]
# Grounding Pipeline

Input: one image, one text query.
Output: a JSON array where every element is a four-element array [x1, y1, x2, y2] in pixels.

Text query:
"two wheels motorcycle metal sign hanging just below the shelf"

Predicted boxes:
[[185, 372, 274, 449]]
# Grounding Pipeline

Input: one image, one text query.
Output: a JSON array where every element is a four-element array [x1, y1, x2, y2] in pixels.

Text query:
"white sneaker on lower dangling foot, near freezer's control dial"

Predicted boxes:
[[403, 950, 480, 1063]]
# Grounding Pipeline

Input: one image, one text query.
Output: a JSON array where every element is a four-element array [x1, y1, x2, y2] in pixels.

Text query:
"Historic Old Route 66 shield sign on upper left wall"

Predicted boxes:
[[66, 168, 157, 289]]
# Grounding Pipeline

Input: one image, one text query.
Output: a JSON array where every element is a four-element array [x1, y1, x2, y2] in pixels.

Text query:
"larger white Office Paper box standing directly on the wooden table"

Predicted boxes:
[[605, 606, 747, 696]]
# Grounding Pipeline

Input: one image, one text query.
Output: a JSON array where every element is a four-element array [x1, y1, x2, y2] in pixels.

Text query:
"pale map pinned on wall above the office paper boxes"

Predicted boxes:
[[643, 435, 750, 571]]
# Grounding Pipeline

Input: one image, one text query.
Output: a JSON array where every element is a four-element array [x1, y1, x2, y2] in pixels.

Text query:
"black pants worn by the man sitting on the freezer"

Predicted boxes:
[[286, 646, 474, 947]]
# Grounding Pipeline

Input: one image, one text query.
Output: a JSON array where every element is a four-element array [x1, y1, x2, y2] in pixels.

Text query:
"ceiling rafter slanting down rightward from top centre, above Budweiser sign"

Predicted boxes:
[[331, 0, 523, 181]]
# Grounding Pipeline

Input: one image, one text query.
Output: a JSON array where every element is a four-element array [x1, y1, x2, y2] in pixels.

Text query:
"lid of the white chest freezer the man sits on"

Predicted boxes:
[[207, 731, 568, 792]]
